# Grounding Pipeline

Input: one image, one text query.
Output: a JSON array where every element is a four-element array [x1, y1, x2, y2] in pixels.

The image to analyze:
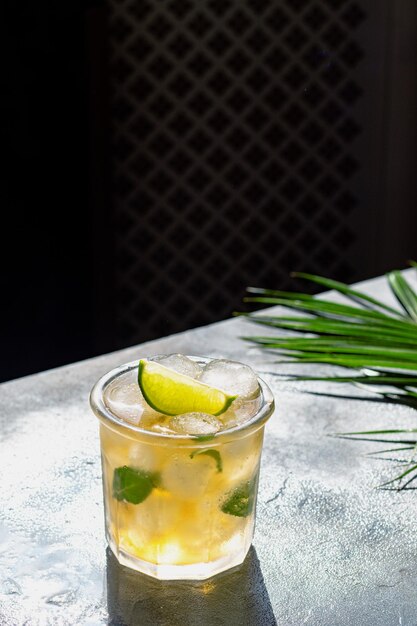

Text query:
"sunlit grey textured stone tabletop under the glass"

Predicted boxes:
[[0, 271, 417, 626]]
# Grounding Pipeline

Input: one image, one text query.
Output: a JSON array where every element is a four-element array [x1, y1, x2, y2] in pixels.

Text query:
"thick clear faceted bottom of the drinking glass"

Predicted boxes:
[[109, 541, 251, 580]]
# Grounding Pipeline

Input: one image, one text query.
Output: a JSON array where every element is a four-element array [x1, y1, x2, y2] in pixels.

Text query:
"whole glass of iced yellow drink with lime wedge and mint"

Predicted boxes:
[[90, 354, 274, 580]]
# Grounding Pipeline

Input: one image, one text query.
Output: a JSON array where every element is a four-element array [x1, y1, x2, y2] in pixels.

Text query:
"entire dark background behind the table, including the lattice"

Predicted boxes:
[[0, 0, 417, 380]]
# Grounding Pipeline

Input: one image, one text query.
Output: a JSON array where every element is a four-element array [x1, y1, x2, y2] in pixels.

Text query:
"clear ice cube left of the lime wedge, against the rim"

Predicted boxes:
[[104, 372, 160, 427]]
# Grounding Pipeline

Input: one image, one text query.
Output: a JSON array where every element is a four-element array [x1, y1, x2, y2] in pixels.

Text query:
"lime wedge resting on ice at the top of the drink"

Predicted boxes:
[[138, 359, 236, 415]]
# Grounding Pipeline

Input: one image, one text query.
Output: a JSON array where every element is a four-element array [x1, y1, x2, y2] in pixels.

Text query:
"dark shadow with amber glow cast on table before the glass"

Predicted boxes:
[[107, 546, 277, 626]]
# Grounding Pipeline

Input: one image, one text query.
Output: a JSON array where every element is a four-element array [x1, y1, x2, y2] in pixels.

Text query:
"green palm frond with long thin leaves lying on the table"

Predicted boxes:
[[241, 261, 417, 488]]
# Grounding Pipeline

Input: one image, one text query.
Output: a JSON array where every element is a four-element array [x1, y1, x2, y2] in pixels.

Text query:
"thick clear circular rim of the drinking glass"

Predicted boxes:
[[90, 355, 275, 444]]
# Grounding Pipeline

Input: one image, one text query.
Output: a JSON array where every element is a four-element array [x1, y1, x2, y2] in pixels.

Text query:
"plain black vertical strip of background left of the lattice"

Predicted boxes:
[[0, 2, 94, 380]]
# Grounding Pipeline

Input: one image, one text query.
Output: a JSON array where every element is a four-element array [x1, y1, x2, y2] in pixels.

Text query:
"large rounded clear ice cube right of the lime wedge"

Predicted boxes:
[[200, 359, 259, 398]]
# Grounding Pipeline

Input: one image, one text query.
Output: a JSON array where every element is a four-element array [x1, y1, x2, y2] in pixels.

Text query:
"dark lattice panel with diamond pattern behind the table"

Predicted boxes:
[[110, 0, 366, 345]]
